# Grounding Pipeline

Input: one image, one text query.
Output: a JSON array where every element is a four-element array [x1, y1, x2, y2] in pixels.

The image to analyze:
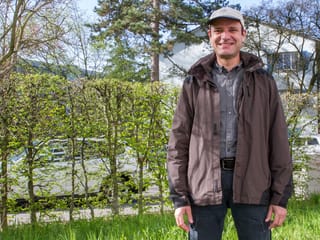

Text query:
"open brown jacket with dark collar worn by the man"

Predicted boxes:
[[167, 52, 292, 208]]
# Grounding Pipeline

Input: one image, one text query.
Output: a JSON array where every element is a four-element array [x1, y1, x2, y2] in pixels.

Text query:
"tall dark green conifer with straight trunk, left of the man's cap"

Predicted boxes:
[[93, 0, 236, 82]]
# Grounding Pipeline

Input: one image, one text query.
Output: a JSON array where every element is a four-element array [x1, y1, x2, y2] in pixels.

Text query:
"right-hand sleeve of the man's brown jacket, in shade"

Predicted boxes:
[[269, 76, 293, 207]]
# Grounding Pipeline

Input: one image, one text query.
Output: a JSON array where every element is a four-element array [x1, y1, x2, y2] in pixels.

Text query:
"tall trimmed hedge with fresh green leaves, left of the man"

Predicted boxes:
[[1, 74, 178, 228]]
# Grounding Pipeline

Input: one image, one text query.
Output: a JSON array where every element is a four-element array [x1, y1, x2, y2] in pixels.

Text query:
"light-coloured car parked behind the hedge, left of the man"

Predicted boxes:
[[9, 138, 142, 204]]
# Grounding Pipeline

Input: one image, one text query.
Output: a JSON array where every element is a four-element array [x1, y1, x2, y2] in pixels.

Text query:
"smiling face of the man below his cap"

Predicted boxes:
[[208, 18, 246, 60]]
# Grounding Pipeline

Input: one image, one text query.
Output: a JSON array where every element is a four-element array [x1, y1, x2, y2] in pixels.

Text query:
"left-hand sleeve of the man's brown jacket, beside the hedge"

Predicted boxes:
[[167, 77, 194, 208]]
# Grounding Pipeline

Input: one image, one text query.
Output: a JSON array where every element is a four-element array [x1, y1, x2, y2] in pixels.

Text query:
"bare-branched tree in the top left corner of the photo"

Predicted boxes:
[[0, 0, 68, 78]]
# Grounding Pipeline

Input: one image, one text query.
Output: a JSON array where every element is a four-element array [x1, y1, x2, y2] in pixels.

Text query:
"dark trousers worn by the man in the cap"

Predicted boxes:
[[189, 171, 271, 240]]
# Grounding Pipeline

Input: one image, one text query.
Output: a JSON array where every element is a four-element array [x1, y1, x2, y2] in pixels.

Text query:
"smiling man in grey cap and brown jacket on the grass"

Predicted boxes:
[[167, 7, 292, 240]]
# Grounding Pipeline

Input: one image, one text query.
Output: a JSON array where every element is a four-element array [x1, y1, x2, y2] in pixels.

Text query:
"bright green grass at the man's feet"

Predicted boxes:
[[0, 196, 320, 240]]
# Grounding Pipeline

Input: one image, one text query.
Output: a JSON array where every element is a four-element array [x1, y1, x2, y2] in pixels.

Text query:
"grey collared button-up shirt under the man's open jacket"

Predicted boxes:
[[213, 63, 243, 158]]
